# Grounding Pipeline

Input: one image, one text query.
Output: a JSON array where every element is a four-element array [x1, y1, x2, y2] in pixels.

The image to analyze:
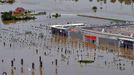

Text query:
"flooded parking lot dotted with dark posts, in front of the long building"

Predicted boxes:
[[0, 19, 134, 75]]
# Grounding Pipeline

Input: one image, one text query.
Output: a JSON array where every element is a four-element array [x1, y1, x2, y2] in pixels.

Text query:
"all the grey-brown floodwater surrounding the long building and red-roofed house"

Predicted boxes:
[[0, 0, 134, 75]]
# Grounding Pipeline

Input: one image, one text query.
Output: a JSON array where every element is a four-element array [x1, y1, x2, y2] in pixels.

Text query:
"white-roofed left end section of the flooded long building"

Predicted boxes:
[[50, 23, 85, 37]]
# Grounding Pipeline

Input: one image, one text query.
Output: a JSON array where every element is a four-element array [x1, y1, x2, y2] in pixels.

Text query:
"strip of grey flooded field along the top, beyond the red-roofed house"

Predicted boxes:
[[0, 0, 133, 16]]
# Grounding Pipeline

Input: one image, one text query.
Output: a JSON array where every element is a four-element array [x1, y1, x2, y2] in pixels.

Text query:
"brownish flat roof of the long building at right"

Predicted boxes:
[[83, 25, 134, 37]]
